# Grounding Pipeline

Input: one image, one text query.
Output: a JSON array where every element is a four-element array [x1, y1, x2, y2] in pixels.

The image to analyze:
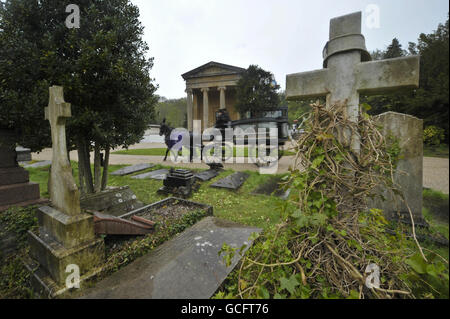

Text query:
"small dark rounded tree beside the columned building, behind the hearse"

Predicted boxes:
[[235, 65, 280, 115]]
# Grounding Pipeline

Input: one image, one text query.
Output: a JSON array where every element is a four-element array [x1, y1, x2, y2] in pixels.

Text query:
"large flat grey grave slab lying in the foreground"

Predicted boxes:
[[82, 217, 261, 299]]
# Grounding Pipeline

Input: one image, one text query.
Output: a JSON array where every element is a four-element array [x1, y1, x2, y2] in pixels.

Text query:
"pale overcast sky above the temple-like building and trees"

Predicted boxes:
[[132, 0, 449, 98]]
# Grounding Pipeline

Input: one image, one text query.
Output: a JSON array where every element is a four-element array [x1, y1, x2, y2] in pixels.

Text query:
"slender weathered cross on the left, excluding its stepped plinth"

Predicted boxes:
[[45, 86, 80, 216]]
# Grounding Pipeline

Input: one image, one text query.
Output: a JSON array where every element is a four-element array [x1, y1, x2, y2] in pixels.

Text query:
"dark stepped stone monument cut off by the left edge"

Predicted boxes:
[[0, 129, 47, 211]]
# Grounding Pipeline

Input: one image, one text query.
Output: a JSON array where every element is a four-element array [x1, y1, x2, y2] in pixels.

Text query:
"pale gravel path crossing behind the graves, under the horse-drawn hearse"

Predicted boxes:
[[32, 147, 449, 194]]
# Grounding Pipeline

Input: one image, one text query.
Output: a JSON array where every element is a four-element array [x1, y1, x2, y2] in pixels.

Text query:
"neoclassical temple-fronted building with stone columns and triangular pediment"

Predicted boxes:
[[181, 62, 245, 131]]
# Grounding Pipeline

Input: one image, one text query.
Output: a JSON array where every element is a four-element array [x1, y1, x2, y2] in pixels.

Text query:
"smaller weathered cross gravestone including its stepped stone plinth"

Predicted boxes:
[[27, 86, 104, 295]]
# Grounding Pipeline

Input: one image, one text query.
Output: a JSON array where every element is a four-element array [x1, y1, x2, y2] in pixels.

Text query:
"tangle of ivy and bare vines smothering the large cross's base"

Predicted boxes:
[[218, 103, 423, 298]]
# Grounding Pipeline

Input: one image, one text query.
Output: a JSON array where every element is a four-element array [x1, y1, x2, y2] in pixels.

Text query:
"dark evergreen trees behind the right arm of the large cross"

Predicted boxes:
[[361, 14, 449, 143]]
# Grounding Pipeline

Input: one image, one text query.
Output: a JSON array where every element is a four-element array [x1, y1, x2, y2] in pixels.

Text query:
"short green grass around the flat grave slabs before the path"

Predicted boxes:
[[28, 162, 290, 228]]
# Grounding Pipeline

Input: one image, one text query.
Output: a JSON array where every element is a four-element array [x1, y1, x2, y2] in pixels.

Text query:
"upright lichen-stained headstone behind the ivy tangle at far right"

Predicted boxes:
[[371, 112, 426, 226]]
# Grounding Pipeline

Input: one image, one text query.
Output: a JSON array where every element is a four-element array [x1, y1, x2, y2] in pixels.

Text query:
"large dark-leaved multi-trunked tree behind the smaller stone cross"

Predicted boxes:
[[0, 0, 157, 193]]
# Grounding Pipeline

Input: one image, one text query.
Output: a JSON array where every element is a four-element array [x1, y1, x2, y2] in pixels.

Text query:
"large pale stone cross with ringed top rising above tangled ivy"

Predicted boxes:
[[286, 12, 419, 155]]
